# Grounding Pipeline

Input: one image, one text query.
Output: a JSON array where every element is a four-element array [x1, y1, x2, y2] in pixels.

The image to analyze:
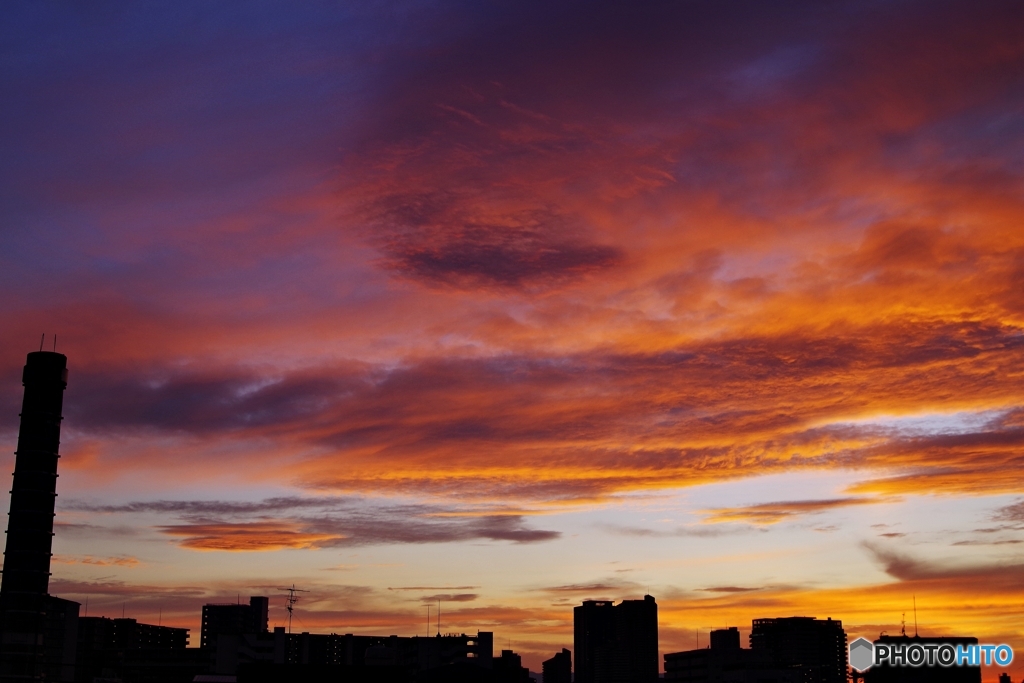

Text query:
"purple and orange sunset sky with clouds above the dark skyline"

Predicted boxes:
[[0, 0, 1024, 681]]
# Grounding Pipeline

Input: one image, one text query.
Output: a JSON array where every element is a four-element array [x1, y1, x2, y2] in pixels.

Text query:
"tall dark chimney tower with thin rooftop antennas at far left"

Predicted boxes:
[[0, 351, 68, 681]]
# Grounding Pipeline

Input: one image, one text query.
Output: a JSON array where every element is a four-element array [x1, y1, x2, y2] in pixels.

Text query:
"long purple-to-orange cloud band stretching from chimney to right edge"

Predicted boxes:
[[39, 321, 1024, 502]]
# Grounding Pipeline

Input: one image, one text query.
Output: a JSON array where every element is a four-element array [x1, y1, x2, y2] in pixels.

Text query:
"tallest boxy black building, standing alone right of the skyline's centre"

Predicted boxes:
[[572, 595, 658, 683]]
